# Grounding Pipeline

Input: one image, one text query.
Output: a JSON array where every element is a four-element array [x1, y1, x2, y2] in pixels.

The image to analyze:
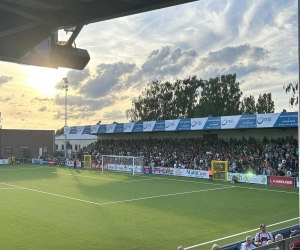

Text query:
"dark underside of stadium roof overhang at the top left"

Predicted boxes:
[[0, 0, 196, 69]]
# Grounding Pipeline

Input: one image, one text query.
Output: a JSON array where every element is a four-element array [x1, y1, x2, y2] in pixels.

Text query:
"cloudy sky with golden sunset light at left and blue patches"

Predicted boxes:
[[0, 0, 298, 130]]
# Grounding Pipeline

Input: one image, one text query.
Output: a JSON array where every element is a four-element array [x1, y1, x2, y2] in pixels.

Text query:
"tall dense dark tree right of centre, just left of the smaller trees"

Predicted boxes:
[[194, 74, 243, 117]]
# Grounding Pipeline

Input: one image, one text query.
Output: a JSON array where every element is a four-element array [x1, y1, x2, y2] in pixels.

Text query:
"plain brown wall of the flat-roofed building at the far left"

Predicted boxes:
[[0, 129, 54, 159]]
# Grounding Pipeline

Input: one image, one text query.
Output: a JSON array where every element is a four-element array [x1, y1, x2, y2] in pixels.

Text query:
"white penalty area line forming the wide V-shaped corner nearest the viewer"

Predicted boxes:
[[0, 182, 232, 206]]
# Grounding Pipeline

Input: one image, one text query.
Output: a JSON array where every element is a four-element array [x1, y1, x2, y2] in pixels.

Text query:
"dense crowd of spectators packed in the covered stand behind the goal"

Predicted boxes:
[[78, 136, 299, 177]]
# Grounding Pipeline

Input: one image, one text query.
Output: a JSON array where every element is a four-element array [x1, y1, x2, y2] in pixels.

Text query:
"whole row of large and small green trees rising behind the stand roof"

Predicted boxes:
[[125, 74, 275, 122]]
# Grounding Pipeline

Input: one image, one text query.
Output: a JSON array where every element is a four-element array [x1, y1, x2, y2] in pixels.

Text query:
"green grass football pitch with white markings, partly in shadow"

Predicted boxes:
[[0, 165, 299, 250]]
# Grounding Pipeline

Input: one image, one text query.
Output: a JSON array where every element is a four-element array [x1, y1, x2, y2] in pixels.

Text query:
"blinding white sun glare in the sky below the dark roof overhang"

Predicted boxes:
[[24, 66, 68, 96]]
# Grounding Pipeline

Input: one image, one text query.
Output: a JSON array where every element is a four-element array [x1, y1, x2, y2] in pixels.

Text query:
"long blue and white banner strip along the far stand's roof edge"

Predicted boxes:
[[64, 112, 298, 134]]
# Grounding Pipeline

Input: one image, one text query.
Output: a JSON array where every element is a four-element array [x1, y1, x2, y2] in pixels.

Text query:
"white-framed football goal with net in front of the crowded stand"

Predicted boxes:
[[101, 155, 143, 175]]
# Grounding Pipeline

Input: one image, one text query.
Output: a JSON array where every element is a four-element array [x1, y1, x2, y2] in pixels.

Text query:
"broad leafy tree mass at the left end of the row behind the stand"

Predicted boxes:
[[125, 76, 203, 121]]
